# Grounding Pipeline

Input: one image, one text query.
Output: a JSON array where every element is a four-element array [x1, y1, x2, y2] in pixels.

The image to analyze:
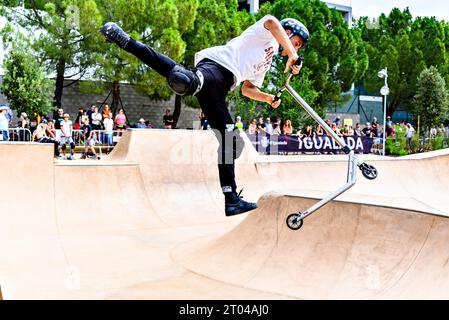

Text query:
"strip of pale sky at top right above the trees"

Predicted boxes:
[[328, 0, 449, 22]]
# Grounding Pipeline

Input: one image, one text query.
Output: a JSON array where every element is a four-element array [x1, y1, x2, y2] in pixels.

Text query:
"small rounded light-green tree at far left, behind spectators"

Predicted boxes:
[[1, 49, 54, 115]]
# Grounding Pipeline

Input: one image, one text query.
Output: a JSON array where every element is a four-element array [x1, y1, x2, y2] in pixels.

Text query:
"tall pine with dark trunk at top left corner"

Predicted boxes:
[[0, 0, 100, 106]]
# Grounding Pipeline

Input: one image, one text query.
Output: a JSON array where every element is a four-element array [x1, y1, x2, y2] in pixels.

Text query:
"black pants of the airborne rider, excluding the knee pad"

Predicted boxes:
[[125, 39, 243, 192]]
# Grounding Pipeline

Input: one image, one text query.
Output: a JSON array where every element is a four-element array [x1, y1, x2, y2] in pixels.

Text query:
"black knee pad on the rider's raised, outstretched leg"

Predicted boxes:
[[168, 65, 203, 96]]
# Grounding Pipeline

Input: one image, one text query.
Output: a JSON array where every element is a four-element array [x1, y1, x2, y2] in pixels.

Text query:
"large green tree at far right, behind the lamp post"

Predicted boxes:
[[355, 8, 449, 115]]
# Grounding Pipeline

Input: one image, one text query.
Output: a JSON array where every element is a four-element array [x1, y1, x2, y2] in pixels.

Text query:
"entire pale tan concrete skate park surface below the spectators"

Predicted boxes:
[[0, 129, 449, 300]]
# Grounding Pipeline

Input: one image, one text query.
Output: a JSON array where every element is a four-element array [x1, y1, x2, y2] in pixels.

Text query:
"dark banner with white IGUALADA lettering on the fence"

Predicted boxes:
[[248, 134, 373, 154]]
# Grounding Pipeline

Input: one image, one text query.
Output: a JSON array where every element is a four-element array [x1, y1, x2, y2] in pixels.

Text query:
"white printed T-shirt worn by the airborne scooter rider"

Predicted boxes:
[[195, 15, 279, 90]]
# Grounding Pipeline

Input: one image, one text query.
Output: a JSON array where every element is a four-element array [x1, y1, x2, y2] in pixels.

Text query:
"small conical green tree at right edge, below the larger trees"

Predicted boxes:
[[412, 67, 449, 132]]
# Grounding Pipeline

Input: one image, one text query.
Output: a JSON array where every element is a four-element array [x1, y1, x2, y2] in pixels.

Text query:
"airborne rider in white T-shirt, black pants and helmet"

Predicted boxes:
[[100, 15, 309, 216]]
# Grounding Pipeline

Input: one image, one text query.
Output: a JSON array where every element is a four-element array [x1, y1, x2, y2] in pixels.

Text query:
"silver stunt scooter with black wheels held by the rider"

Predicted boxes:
[[274, 57, 377, 230]]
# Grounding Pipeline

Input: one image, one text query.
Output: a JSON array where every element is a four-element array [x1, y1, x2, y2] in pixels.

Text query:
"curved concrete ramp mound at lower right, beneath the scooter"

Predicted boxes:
[[173, 193, 449, 299]]
